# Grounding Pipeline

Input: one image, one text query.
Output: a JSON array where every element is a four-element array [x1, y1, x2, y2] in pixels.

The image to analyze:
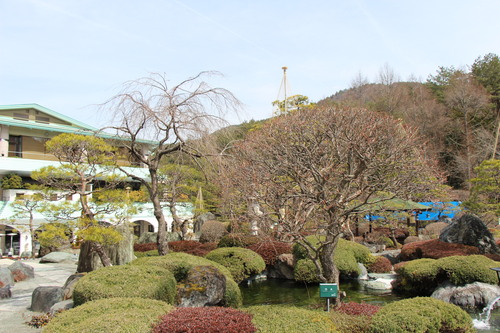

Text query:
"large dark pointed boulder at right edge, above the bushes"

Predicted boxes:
[[439, 214, 500, 254]]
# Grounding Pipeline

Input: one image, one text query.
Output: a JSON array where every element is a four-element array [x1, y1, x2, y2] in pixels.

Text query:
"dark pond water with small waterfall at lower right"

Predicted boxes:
[[240, 279, 500, 333]]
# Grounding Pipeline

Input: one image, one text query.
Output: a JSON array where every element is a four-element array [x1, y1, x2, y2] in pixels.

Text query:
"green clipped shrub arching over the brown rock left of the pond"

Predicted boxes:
[[131, 252, 242, 307]]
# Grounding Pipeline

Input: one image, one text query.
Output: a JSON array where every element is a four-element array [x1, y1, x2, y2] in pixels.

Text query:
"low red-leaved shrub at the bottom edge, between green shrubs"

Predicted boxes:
[[152, 307, 256, 333]]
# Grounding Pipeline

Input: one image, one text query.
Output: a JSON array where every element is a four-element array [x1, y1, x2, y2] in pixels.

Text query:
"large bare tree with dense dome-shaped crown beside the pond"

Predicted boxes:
[[226, 107, 442, 300]]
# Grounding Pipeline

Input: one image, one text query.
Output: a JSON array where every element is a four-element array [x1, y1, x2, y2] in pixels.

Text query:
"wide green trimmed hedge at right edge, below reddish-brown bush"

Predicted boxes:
[[395, 255, 500, 296]]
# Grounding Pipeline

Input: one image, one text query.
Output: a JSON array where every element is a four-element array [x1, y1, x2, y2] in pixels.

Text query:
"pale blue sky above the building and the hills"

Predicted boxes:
[[0, 0, 500, 127]]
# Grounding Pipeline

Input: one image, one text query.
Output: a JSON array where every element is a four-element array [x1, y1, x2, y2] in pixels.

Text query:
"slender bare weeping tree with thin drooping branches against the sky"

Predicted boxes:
[[104, 72, 239, 255]]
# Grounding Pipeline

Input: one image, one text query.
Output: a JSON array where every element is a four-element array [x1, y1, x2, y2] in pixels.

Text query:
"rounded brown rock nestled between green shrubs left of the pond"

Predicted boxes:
[[177, 266, 226, 307]]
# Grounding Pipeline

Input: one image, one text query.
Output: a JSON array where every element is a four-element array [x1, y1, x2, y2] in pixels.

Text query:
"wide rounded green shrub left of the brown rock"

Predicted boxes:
[[73, 264, 176, 305]]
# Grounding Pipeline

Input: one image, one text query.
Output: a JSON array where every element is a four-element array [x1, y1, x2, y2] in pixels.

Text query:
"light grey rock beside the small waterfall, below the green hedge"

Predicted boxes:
[[431, 282, 500, 309]]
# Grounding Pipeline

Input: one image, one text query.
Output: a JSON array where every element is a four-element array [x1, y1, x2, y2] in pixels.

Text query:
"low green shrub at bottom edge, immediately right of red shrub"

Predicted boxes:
[[243, 305, 337, 333]]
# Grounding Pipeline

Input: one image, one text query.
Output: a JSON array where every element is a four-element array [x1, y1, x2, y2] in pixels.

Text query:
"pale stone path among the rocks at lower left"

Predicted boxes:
[[0, 259, 76, 333]]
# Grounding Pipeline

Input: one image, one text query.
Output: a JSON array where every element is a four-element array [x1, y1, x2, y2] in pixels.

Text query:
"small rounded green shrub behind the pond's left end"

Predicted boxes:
[[205, 247, 266, 283]]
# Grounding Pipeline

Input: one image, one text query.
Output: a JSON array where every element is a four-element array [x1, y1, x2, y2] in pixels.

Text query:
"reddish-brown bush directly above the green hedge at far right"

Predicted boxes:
[[400, 239, 479, 261]]
